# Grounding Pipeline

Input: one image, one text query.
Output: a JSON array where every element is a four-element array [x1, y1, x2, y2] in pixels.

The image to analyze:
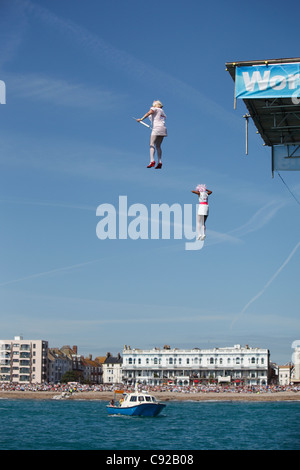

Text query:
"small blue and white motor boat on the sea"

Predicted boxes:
[[107, 390, 166, 416]]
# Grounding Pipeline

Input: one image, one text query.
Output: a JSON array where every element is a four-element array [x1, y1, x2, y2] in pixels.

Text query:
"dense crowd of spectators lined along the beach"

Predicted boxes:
[[0, 383, 300, 394]]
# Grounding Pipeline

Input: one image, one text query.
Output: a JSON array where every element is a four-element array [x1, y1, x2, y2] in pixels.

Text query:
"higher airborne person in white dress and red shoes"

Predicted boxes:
[[137, 101, 168, 169]]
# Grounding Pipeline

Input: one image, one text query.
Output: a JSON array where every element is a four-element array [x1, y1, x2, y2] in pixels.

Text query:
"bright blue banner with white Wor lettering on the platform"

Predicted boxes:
[[235, 63, 300, 101]]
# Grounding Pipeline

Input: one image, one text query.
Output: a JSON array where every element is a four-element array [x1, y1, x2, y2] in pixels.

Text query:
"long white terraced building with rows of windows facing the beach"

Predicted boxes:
[[123, 345, 270, 385]]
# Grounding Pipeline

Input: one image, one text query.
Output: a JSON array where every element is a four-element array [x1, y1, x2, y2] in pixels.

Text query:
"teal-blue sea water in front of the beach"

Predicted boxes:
[[0, 399, 300, 451]]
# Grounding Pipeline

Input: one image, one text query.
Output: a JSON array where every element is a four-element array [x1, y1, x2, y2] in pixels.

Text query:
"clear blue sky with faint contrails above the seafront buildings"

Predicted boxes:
[[0, 0, 300, 363]]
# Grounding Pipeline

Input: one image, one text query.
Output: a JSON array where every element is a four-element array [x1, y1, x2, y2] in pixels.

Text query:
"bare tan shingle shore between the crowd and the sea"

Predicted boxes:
[[0, 391, 300, 402]]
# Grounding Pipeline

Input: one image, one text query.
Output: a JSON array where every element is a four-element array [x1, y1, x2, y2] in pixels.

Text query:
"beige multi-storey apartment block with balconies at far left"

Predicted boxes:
[[0, 336, 48, 384]]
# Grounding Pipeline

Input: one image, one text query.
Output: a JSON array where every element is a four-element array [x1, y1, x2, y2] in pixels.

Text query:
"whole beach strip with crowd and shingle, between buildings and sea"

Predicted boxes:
[[0, 384, 300, 401]]
